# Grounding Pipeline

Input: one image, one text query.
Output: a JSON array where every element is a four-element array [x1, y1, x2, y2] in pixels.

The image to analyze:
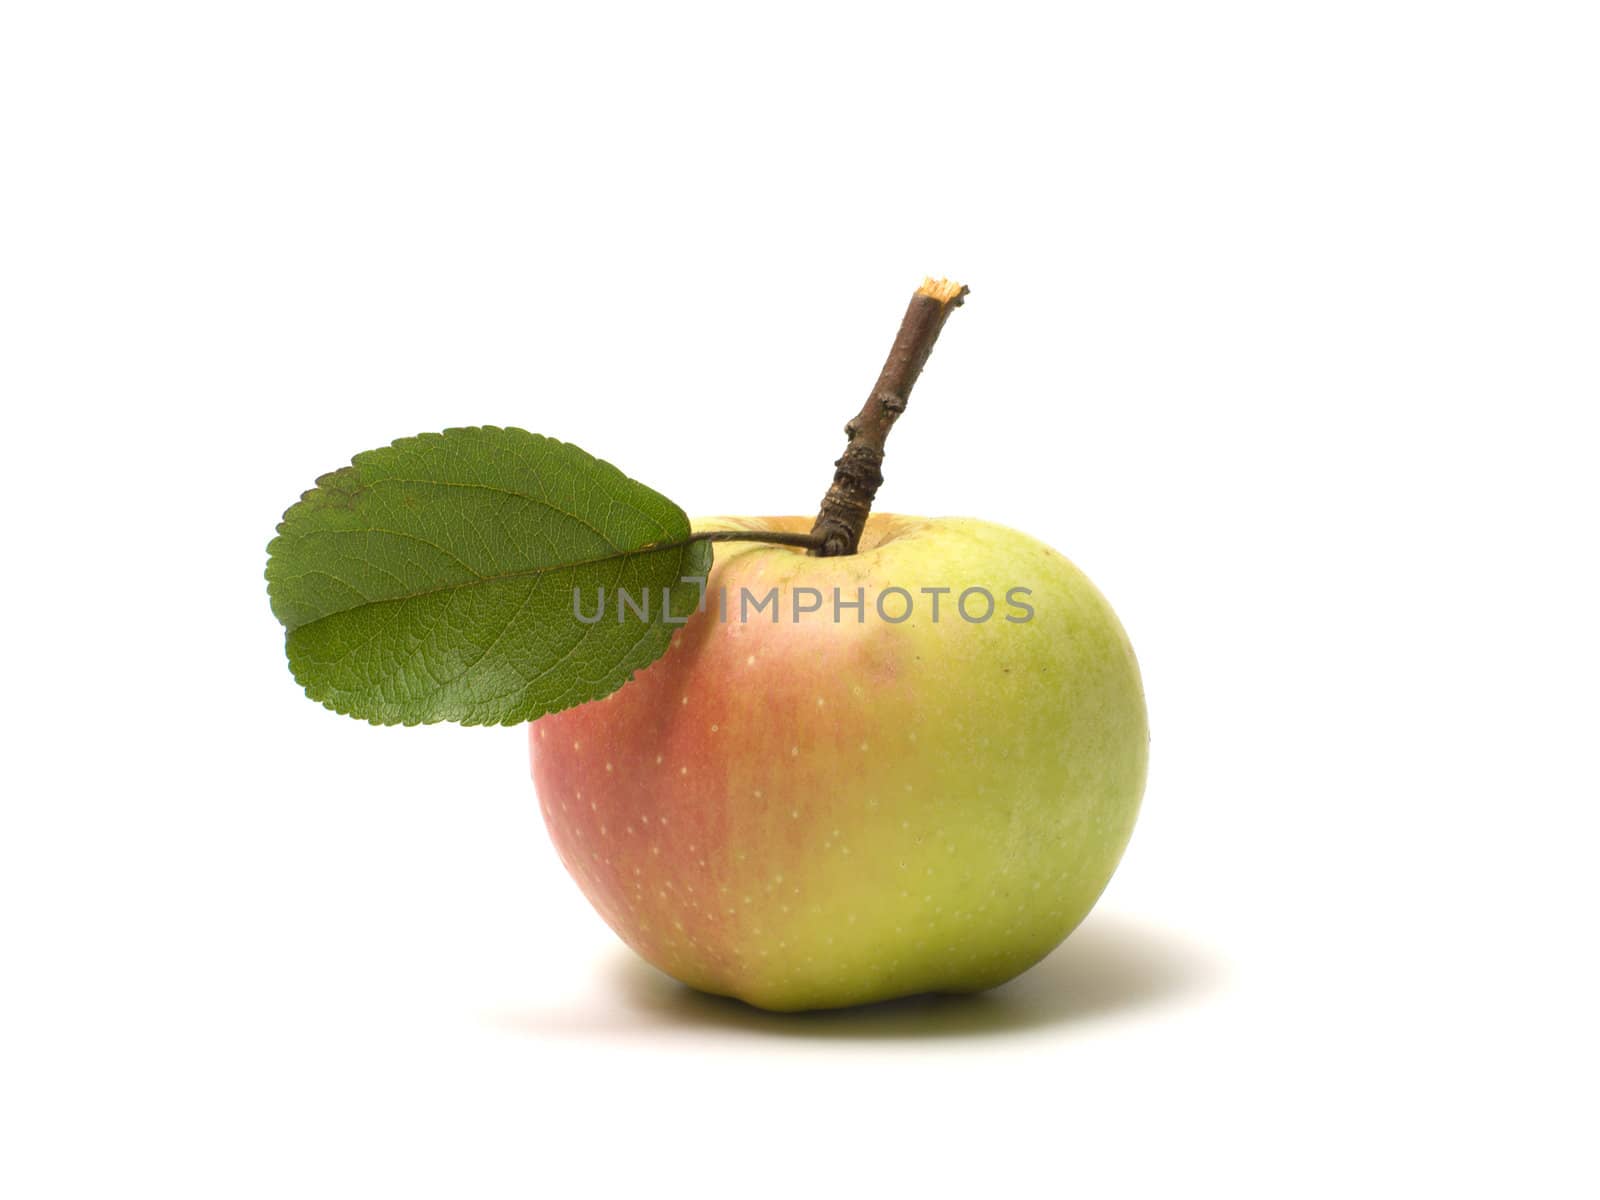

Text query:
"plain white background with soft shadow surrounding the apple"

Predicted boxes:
[[0, 0, 1600, 1197]]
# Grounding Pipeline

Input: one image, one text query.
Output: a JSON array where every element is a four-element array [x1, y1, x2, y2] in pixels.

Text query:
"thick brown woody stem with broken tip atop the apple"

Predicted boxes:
[[811, 278, 968, 558]]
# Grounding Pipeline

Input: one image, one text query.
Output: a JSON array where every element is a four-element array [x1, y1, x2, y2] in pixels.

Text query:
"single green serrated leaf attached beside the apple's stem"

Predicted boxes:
[[267, 426, 710, 725]]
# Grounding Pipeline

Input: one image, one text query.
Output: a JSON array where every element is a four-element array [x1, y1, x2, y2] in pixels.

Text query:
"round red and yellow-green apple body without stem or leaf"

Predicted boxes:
[[528, 514, 1149, 1011]]
